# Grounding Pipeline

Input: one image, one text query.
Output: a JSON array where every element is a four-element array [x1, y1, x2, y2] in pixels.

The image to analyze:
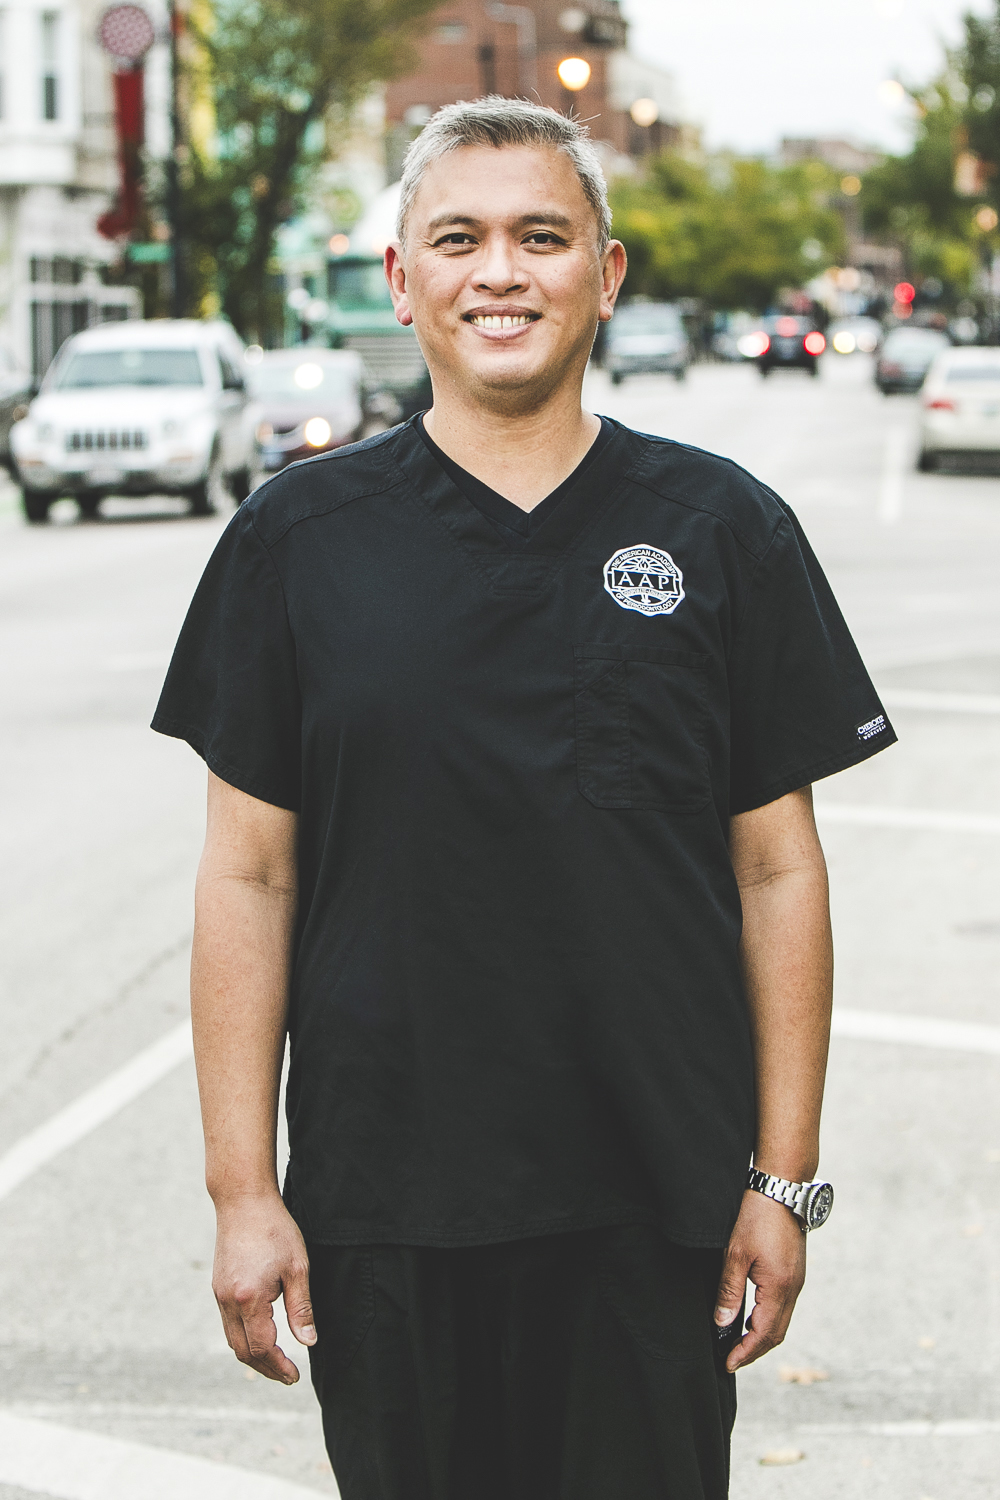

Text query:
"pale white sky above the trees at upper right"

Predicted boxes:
[[622, 0, 994, 153]]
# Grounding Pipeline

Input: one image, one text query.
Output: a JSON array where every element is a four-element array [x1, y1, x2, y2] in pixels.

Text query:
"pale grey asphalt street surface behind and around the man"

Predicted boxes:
[[0, 356, 1000, 1500]]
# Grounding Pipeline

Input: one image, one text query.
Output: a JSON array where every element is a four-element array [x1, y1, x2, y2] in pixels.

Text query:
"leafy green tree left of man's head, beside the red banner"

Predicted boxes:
[[180, 0, 439, 338]]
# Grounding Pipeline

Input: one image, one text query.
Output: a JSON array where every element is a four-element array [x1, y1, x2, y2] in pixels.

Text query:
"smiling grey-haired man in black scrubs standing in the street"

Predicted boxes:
[[154, 99, 895, 1500]]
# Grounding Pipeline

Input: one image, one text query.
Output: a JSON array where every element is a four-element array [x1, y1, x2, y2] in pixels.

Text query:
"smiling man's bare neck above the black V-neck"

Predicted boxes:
[[424, 381, 601, 510]]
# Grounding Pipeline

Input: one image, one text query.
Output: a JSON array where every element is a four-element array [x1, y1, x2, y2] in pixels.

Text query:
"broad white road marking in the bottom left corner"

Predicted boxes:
[[0, 1412, 332, 1500]]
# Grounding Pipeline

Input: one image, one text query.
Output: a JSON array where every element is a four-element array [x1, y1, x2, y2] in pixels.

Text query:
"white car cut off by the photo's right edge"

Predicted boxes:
[[918, 348, 1000, 471]]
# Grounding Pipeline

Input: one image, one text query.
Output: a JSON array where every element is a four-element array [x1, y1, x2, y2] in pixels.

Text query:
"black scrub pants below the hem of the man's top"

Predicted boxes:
[[309, 1227, 742, 1500]]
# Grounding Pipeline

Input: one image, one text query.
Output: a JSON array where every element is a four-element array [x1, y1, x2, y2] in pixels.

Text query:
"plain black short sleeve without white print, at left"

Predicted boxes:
[[153, 507, 301, 812]]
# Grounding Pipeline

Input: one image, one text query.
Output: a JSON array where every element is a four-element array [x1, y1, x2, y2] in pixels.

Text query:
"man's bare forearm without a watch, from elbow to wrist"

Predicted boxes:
[[190, 855, 295, 1206]]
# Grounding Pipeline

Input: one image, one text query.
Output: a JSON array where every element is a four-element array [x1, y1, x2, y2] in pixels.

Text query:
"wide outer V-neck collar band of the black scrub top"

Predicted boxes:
[[393, 417, 645, 596]]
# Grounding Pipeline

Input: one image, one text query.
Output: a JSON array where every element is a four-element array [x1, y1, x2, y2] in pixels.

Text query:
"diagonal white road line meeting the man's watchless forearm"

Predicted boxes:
[[0, 1022, 192, 1199]]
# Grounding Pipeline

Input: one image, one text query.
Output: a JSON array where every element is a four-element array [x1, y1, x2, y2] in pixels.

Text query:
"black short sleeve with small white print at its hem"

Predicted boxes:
[[730, 510, 897, 813]]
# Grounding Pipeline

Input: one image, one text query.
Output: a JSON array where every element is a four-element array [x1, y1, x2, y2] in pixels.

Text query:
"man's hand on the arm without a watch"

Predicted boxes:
[[211, 1193, 316, 1386]]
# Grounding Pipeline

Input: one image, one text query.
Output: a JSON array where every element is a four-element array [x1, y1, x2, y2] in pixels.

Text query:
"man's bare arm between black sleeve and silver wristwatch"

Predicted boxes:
[[735, 789, 834, 1182]]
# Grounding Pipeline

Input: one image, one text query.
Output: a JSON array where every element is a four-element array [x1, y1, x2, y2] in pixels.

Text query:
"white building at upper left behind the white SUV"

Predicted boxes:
[[0, 0, 168, 377]]
